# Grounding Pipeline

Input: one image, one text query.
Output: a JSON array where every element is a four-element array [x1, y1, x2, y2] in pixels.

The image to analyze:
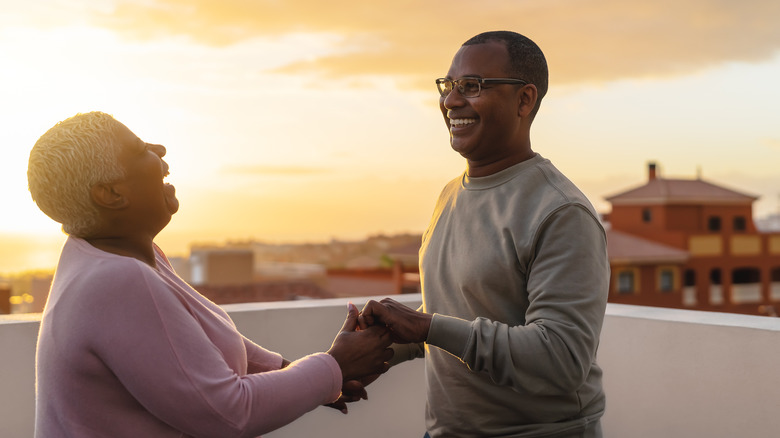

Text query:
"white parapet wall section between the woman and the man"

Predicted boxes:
[[225, 294, 425, 438]]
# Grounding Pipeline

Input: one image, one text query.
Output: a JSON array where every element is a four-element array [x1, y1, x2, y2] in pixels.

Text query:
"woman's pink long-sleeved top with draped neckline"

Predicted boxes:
[[35, 237, 342, 438]]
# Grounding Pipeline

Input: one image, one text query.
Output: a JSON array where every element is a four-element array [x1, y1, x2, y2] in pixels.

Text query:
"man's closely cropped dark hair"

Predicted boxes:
[[463, 30, 549, 117]]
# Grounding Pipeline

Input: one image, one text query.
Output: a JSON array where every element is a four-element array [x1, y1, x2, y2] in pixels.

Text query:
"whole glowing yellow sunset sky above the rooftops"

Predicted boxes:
[[0, 0, 780, 273]]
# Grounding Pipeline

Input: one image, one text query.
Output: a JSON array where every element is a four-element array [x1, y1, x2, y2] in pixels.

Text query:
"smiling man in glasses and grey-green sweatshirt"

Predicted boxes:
[[361, 31, 609, 438]]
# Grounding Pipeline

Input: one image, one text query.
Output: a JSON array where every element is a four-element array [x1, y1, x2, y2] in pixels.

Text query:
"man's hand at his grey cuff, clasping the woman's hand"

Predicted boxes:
[[359, 298, 433, 344]]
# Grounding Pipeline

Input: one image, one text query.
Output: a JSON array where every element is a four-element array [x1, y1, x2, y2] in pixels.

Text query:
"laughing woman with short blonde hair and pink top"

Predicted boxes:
[[27, 112, 392, 438]]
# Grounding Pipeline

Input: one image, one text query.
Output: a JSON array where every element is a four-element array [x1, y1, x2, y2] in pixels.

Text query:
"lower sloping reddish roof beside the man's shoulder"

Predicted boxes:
[[607, 230, 689, 264]]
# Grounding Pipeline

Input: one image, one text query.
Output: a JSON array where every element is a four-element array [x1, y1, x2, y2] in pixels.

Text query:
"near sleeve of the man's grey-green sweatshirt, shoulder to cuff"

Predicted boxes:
[[427, 204, 609, 395]]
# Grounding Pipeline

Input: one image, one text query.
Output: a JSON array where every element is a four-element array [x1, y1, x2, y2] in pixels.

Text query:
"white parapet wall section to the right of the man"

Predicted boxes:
[[599, 304, 780, 438]]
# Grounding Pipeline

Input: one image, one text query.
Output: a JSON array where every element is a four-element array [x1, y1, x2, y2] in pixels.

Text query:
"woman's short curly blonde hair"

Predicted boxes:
[[27, 112, 124, 237]]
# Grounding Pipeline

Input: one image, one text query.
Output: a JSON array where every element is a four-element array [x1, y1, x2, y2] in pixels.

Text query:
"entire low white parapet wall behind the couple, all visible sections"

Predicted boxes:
[[0, 295, 780, 438]]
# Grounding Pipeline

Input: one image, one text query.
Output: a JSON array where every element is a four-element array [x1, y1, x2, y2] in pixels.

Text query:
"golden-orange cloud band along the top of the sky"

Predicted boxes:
[[96, 0, 780, 87]]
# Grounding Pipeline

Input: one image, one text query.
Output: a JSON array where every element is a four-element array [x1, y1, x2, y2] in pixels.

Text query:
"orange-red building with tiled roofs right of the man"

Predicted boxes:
[[606, 163, 780, 315]]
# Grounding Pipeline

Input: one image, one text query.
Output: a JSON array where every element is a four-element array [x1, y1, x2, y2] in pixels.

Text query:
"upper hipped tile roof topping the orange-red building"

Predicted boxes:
[[604, 178, 758, 205]]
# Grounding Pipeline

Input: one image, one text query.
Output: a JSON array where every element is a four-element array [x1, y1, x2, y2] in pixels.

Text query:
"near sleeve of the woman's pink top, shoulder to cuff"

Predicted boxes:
[[85, 266, 342, 437]]
